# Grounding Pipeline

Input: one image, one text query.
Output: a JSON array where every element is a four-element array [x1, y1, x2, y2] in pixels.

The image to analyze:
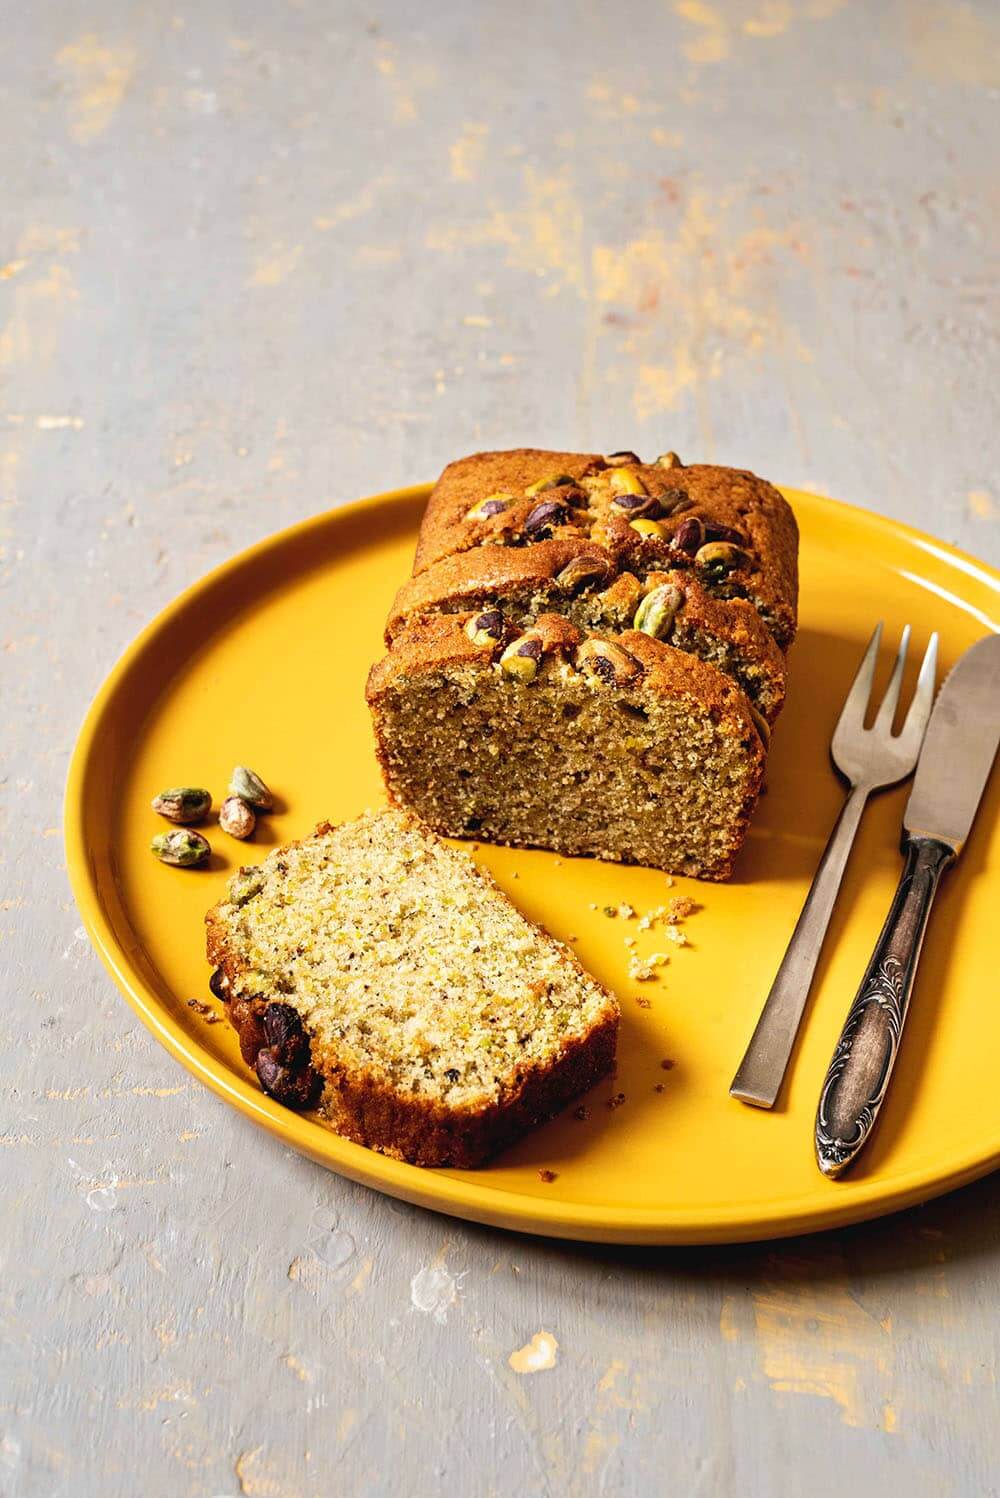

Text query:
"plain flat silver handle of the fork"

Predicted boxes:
[[729, 785, 868, 1109]]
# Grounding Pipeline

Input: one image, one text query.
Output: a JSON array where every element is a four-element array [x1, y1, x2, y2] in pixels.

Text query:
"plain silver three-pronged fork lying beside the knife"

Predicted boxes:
[[729, 623, 937, 1109]]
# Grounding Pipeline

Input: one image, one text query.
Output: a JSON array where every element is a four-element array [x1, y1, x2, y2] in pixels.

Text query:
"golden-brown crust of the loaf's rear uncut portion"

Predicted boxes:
[[413, 448, 798, 649]]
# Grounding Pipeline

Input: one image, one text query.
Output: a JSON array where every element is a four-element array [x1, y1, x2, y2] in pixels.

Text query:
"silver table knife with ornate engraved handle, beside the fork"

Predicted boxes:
[[816, 635, 1000, 1177]]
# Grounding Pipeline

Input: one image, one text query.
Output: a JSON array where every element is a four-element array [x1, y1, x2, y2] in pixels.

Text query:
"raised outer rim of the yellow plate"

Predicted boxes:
[[63, 484, 1000, 1245]]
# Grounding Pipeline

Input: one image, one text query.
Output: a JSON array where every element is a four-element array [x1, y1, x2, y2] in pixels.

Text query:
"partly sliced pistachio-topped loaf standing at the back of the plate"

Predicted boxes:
[[368, 448, 798, 879]]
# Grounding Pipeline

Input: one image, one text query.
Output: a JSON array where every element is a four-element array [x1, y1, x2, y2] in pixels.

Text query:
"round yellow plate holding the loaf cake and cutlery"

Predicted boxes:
[[66, 488, 1000, 1243]]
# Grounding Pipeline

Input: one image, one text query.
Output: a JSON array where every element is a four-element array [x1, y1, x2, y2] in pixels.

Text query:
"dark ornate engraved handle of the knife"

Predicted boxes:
[[816, 837, 955, 1177]]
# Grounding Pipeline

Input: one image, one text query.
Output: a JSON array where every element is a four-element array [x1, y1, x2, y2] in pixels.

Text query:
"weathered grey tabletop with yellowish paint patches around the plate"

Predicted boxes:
[[0, 0, 1000, 1498]]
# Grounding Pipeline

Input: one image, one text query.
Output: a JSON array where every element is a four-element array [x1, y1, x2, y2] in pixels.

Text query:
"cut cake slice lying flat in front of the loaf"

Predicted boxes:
[[205, 809, 618, 1165]]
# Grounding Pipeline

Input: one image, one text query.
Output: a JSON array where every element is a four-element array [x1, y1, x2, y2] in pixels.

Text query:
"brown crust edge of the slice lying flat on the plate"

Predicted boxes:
[[205, 810, 620, 1168]]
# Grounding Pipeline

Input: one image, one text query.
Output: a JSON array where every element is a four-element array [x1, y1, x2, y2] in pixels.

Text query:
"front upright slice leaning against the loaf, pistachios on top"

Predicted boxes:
[[368, 611, 766, 879]]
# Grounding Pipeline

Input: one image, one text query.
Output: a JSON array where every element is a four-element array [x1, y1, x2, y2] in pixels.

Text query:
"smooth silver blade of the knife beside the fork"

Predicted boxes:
[[903, 635, 1000, 854]]
